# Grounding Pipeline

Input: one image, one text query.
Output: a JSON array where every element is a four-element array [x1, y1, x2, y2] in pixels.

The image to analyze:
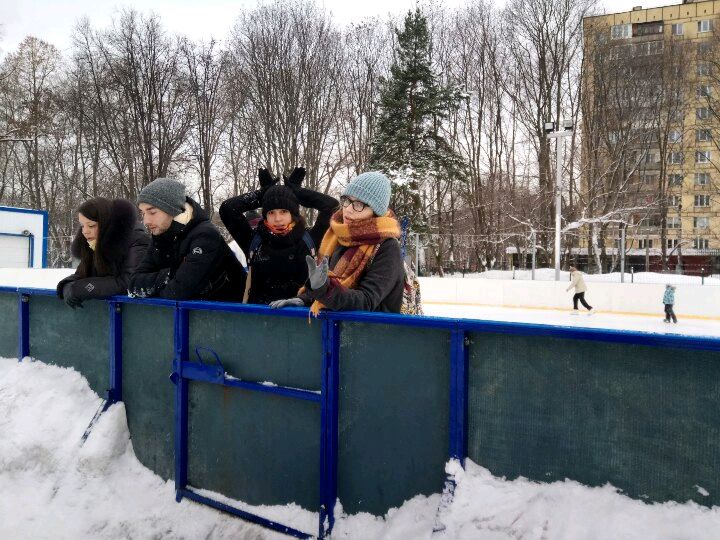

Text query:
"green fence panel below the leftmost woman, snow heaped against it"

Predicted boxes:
[[29, 295, 110, 398]]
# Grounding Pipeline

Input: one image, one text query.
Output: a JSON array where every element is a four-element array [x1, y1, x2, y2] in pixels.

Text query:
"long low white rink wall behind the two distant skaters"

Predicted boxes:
[[420, 277, 720, 317]]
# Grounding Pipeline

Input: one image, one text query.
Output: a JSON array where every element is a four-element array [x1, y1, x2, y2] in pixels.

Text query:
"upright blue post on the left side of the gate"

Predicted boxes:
[[173, 307, 190, 502]]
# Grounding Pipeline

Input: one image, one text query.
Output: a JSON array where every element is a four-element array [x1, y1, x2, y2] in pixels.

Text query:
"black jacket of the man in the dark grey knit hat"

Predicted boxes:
[[128, 198, 245, 302]]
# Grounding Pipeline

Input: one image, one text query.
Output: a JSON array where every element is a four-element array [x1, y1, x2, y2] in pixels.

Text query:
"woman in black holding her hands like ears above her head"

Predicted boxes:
[[220, 167, 338, 304]]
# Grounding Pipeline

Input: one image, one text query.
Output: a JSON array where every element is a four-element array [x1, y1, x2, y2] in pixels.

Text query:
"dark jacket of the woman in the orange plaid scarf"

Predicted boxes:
[[299, 238, 405, 313]]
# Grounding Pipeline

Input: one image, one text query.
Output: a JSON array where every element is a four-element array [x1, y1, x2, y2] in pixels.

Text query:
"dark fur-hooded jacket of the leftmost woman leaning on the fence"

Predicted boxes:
[[57, 199, 150, 300]]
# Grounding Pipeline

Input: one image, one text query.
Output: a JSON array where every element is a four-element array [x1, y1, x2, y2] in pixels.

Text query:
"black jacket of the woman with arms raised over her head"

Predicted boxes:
[[220, 187, 338, 304]]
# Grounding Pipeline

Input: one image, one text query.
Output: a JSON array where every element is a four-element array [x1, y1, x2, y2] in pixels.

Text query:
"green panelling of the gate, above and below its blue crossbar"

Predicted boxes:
[[188, 311, 322, 511]]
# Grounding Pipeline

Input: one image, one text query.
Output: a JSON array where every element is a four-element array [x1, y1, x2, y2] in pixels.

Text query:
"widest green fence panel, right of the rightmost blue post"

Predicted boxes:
[[468, 333, 720, 505]]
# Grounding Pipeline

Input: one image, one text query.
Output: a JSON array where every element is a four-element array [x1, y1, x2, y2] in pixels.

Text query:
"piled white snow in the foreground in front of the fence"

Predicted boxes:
[[0, 358, 720, 540]]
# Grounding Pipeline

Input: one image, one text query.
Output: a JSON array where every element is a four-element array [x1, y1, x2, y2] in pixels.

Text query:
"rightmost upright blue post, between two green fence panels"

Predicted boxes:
[[450, 327, 469, 466]]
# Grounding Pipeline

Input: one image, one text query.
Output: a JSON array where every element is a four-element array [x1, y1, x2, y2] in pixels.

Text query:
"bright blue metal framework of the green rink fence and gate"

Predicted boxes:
[[0, 287, 720, 538]]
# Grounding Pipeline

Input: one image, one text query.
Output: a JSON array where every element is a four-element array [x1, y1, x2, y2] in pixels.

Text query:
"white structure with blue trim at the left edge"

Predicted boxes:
[[0, 206, 48, 268]]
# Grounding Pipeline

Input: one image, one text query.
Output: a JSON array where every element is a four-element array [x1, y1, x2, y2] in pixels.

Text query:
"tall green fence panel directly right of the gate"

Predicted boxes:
[[338, 323, 450, 515]]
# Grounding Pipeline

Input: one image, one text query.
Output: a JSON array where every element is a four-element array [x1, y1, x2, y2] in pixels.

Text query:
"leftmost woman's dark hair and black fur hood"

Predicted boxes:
[[71, 197, 138, 277]]
